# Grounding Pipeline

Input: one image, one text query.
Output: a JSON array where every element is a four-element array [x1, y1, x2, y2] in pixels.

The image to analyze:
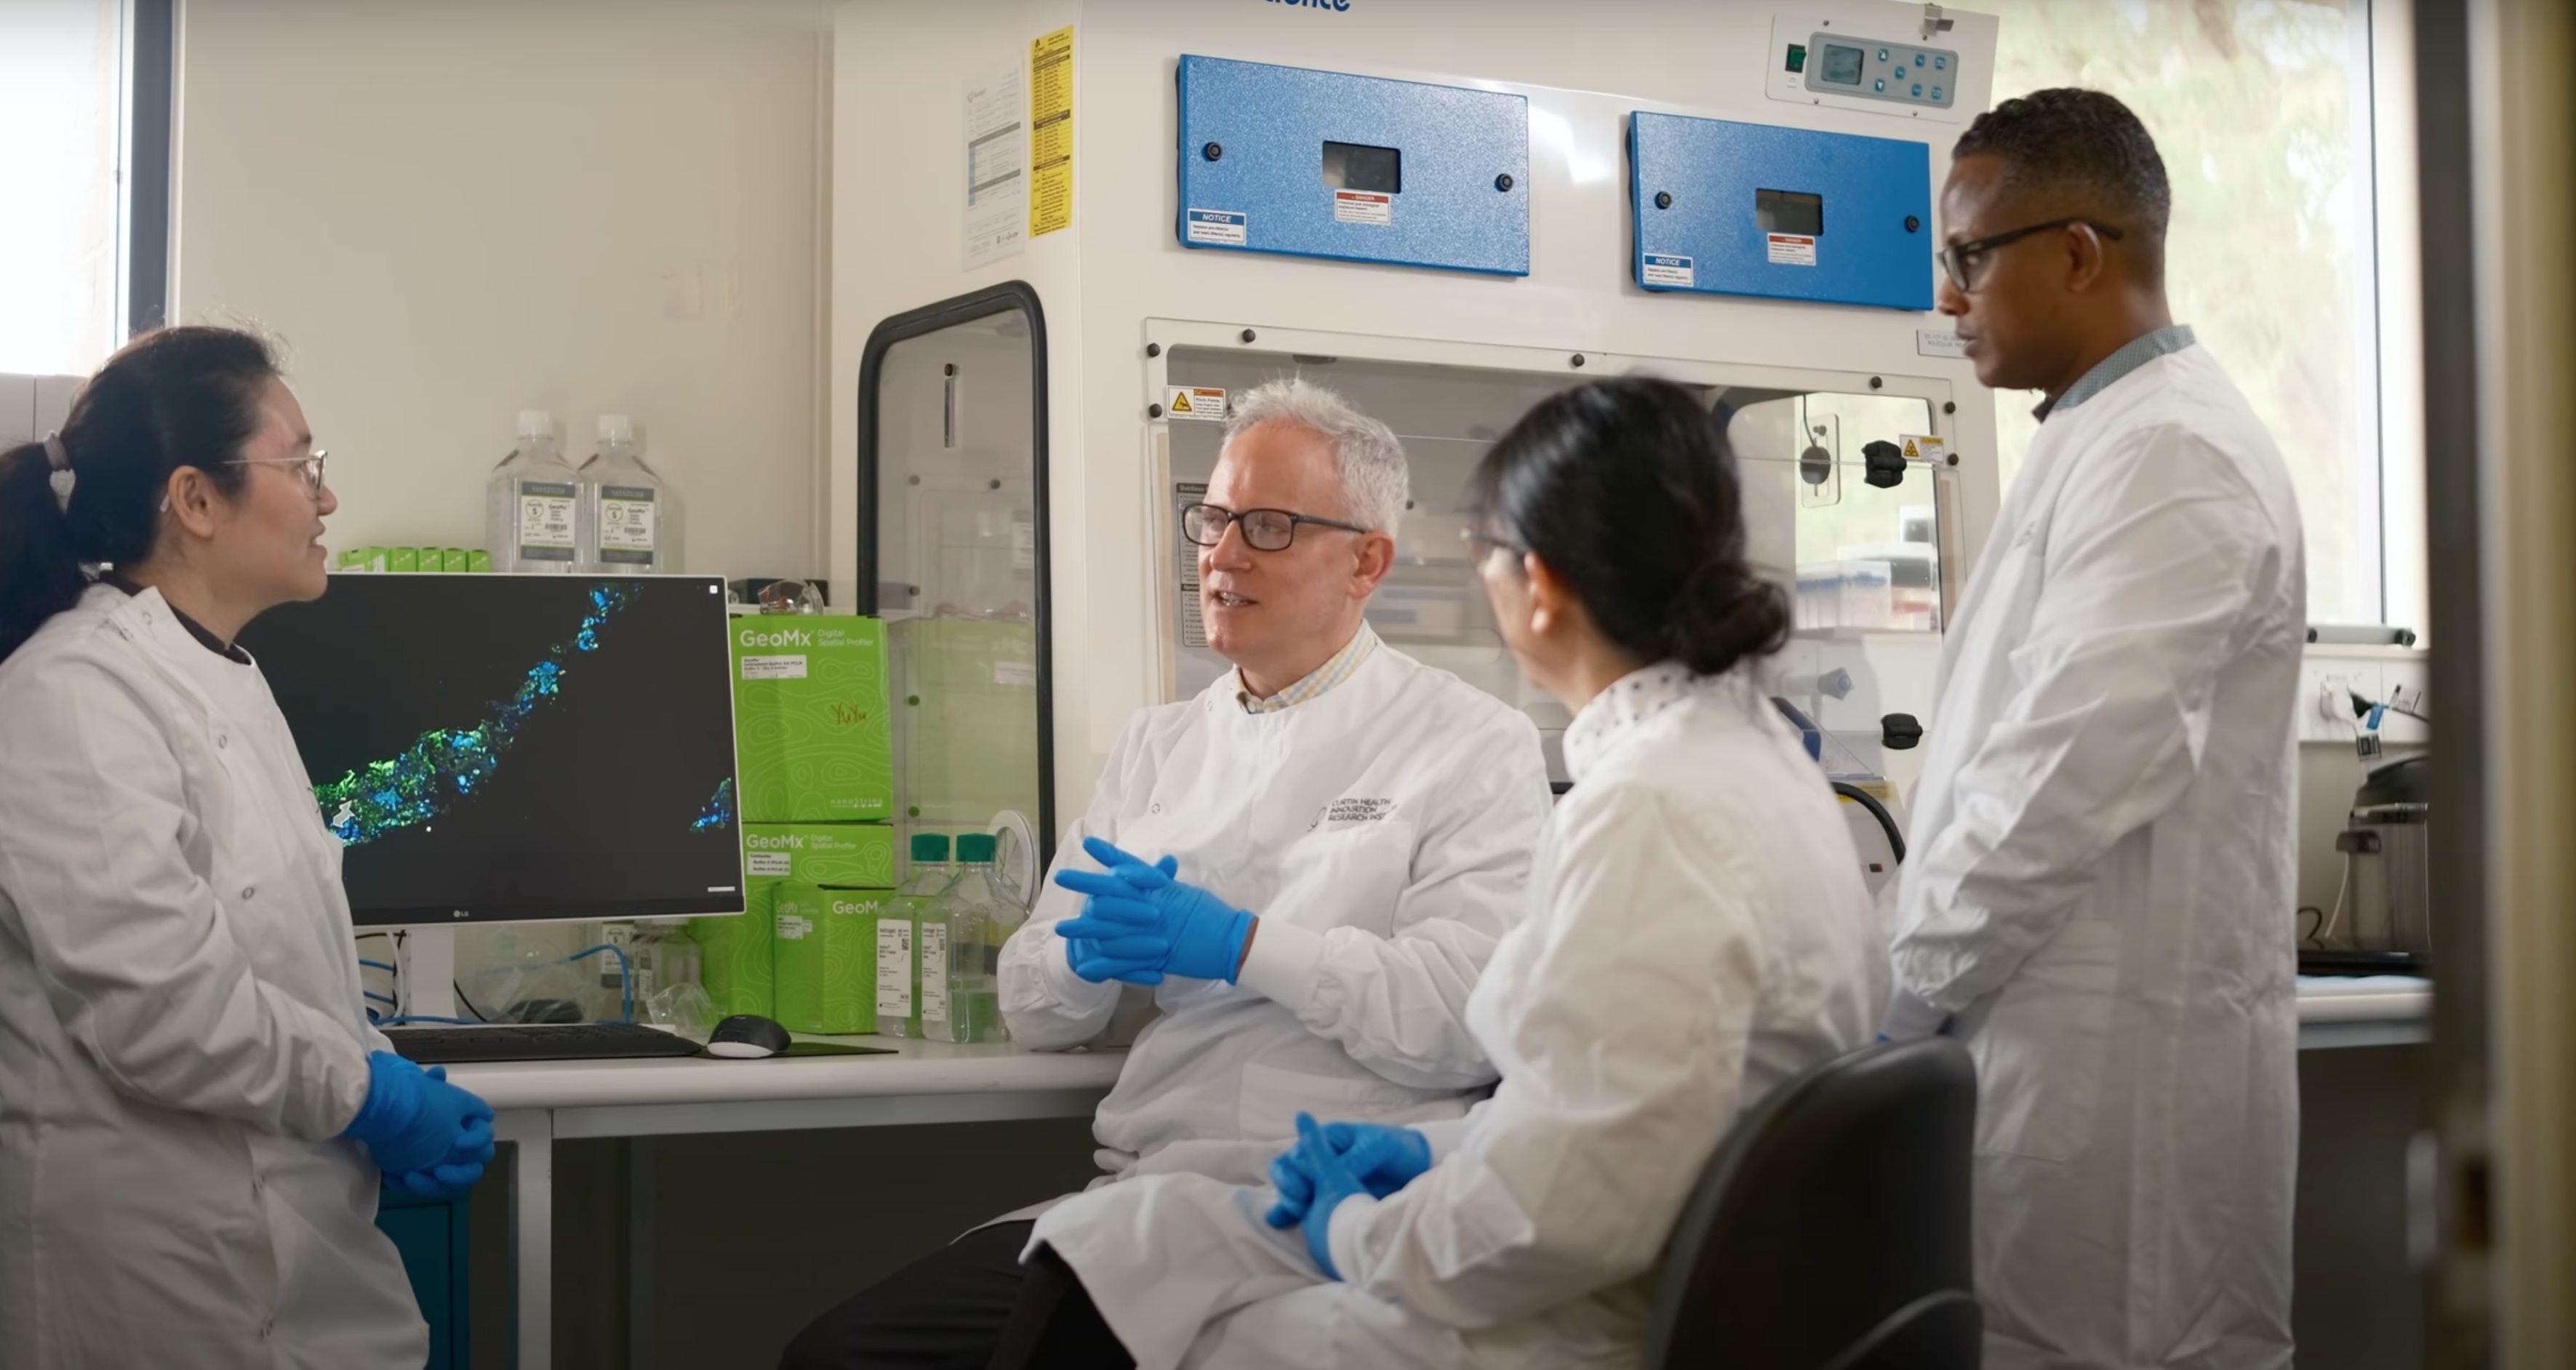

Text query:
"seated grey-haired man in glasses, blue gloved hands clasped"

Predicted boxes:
[[780, 381, 1548, 1370]]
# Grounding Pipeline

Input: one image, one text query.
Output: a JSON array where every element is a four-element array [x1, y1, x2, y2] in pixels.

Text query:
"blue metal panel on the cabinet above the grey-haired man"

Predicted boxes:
[[1175, 57, 1530, 276]]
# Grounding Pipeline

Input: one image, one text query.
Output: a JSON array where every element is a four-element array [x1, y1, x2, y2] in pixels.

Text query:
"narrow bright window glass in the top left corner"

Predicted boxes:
[[0, 0, 124, 376]]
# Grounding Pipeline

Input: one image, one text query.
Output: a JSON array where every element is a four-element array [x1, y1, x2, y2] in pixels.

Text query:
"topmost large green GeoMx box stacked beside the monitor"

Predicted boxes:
[[727, 613, 894, 824]]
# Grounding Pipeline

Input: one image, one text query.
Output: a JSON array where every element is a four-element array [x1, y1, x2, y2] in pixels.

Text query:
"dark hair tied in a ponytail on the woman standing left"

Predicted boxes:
[[0, 327, 279, 660]]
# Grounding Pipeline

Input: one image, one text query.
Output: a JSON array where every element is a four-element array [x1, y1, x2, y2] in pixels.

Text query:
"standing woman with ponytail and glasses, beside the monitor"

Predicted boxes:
[[0, 327, 492, 1370]]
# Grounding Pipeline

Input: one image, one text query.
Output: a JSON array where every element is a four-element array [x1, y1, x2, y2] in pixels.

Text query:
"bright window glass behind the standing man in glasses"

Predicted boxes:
[[1978, 0, 2380, 623]]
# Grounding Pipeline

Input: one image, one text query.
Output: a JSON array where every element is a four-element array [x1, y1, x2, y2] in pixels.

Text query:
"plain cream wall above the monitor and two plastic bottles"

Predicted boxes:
[[172, 0, 832, 577]]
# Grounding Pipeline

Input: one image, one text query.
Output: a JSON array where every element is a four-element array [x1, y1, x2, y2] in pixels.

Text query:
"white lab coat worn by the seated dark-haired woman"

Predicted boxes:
[[1033, 665, 1888, 1370]]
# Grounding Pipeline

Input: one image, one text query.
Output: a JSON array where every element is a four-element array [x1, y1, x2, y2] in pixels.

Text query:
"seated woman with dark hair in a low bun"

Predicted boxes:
[[997, 379, 1888, 1367]]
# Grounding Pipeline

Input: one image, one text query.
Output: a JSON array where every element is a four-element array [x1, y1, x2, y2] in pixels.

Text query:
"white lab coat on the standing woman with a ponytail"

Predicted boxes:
[[0, 587, 431, 1370]]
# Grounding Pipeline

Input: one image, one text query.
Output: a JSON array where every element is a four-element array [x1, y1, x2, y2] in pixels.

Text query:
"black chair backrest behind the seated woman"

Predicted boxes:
[[1641, 1038, 1981, 1370]]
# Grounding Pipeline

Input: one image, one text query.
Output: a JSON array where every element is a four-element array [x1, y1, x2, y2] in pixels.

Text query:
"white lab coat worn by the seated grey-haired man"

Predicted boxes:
[[1002, 641, 1548, 1200]]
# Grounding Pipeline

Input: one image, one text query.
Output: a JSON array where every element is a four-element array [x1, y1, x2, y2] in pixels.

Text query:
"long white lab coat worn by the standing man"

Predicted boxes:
[[1893, 348, 2305, 1370]]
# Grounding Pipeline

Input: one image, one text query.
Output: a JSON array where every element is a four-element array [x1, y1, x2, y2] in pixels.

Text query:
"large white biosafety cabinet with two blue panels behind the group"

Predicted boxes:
[[830, 0, 1996, 850]]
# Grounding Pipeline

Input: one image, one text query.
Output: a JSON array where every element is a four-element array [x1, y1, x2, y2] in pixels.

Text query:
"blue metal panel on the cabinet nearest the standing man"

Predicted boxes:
[[1628, 111, 1935, 309]]
